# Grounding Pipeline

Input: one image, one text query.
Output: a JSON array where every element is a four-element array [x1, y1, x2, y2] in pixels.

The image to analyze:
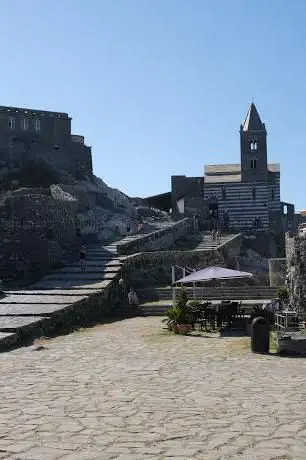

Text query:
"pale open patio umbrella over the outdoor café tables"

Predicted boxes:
[[176, 267, 253, 284]]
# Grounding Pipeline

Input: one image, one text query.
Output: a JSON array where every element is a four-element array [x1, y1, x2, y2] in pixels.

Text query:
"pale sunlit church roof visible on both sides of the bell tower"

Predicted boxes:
[[204, 163, 280, 184]]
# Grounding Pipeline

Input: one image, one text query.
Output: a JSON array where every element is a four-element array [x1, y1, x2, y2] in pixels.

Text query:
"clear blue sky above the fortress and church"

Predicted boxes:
[[0, 0, 306, 209]]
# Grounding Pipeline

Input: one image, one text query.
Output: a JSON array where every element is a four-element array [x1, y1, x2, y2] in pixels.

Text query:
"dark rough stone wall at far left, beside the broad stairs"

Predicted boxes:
[[0, 192, 77, 278]]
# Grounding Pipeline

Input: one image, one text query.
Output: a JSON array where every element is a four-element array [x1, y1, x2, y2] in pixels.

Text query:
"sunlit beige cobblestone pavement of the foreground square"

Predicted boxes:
[[0, 318, 306, 460]]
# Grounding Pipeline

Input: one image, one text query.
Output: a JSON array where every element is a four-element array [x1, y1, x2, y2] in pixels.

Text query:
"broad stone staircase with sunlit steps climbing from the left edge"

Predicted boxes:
[[0, 224, 186, 347]]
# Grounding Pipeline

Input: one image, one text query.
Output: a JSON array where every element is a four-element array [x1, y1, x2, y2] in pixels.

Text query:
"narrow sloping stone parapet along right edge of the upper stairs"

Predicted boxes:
[[117, 218, 194, 255]]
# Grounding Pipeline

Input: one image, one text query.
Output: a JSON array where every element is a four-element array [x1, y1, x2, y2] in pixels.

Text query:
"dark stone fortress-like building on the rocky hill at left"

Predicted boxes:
[[0, 106, 92, 178]]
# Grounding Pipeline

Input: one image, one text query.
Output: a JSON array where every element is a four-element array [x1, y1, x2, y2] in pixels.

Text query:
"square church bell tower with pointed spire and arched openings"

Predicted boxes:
[[240, 102, 268, 182]]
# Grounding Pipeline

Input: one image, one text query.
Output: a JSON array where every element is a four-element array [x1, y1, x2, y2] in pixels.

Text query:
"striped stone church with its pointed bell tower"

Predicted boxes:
[[172, 103, 294, 233]]
